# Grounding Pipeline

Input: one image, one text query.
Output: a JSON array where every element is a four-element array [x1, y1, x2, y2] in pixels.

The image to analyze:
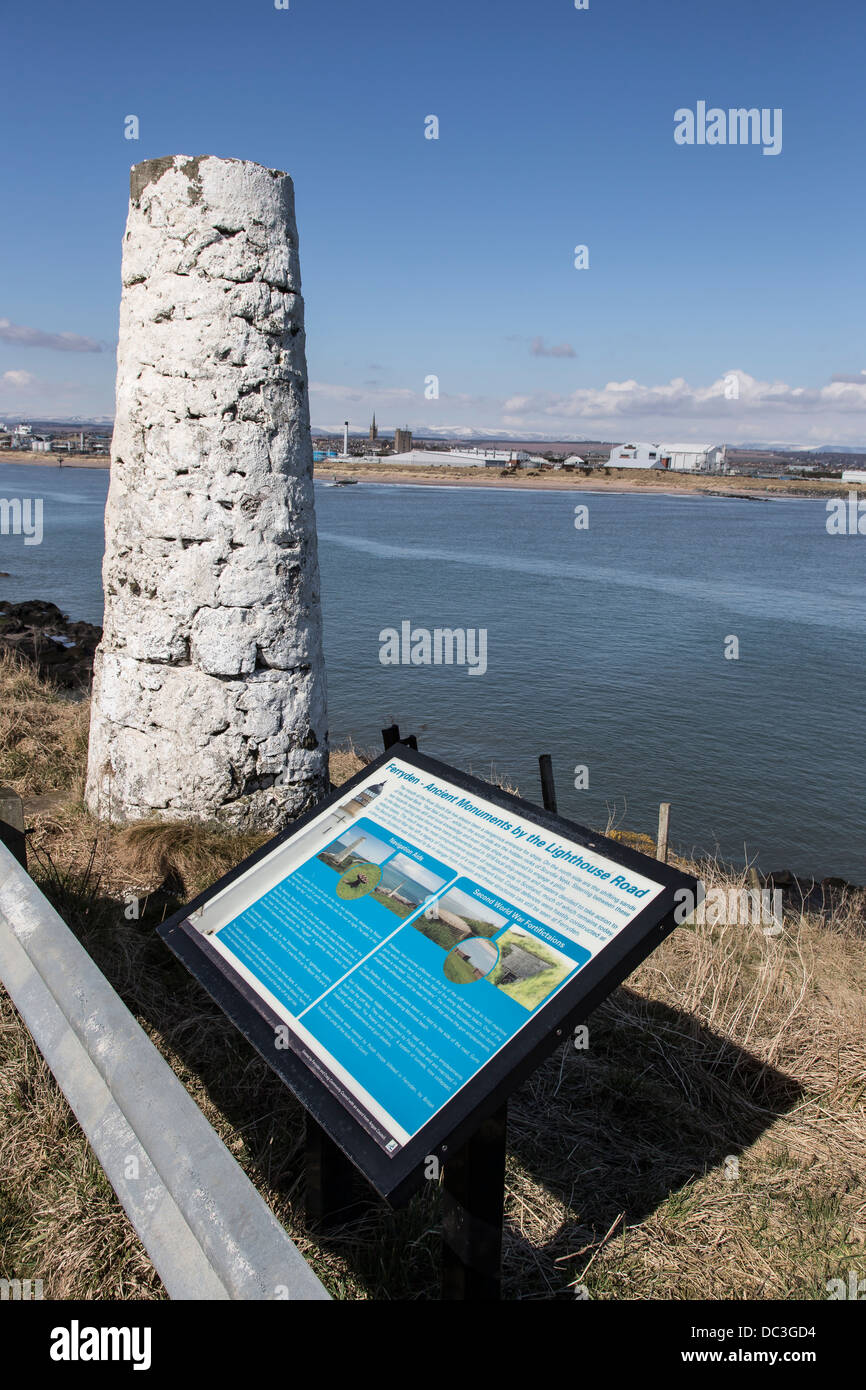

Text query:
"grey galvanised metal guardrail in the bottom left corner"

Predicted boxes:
[[0, 827, 331, 1300]]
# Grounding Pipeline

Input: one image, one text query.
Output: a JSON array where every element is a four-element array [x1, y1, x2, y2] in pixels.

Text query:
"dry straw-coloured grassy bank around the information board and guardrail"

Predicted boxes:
[[0, 660, 866, 1300]]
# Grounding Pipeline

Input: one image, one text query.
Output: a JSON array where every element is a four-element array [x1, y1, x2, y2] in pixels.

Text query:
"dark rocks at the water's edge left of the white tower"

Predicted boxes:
[[0, 599, 103, 691]]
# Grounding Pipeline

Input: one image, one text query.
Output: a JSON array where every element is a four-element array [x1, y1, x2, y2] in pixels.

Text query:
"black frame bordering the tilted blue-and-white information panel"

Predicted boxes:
[[157, 742, 698, 1207]]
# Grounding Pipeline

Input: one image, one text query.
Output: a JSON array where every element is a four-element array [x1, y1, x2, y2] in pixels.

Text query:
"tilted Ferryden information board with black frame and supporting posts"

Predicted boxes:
[[158, 730, 696, 1300]]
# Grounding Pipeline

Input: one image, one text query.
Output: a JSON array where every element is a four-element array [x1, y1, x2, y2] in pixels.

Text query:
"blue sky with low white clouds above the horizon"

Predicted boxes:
[[0, 0, 866, 445]]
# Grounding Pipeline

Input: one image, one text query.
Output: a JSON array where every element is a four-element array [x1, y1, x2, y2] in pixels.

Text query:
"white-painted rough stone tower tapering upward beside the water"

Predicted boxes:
[[86, 156, 328, 827]]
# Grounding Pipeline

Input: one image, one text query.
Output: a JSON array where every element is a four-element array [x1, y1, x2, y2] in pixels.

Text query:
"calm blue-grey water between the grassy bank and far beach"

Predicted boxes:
[[0, 464, 866, 881]]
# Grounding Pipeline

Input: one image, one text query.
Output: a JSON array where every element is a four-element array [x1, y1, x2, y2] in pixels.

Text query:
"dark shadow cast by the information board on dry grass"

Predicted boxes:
[[505, 986, 803, 1298]]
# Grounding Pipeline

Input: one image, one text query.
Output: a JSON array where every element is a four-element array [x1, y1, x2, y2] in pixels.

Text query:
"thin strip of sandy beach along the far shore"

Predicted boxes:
[[0, 450, 847, 502]]
